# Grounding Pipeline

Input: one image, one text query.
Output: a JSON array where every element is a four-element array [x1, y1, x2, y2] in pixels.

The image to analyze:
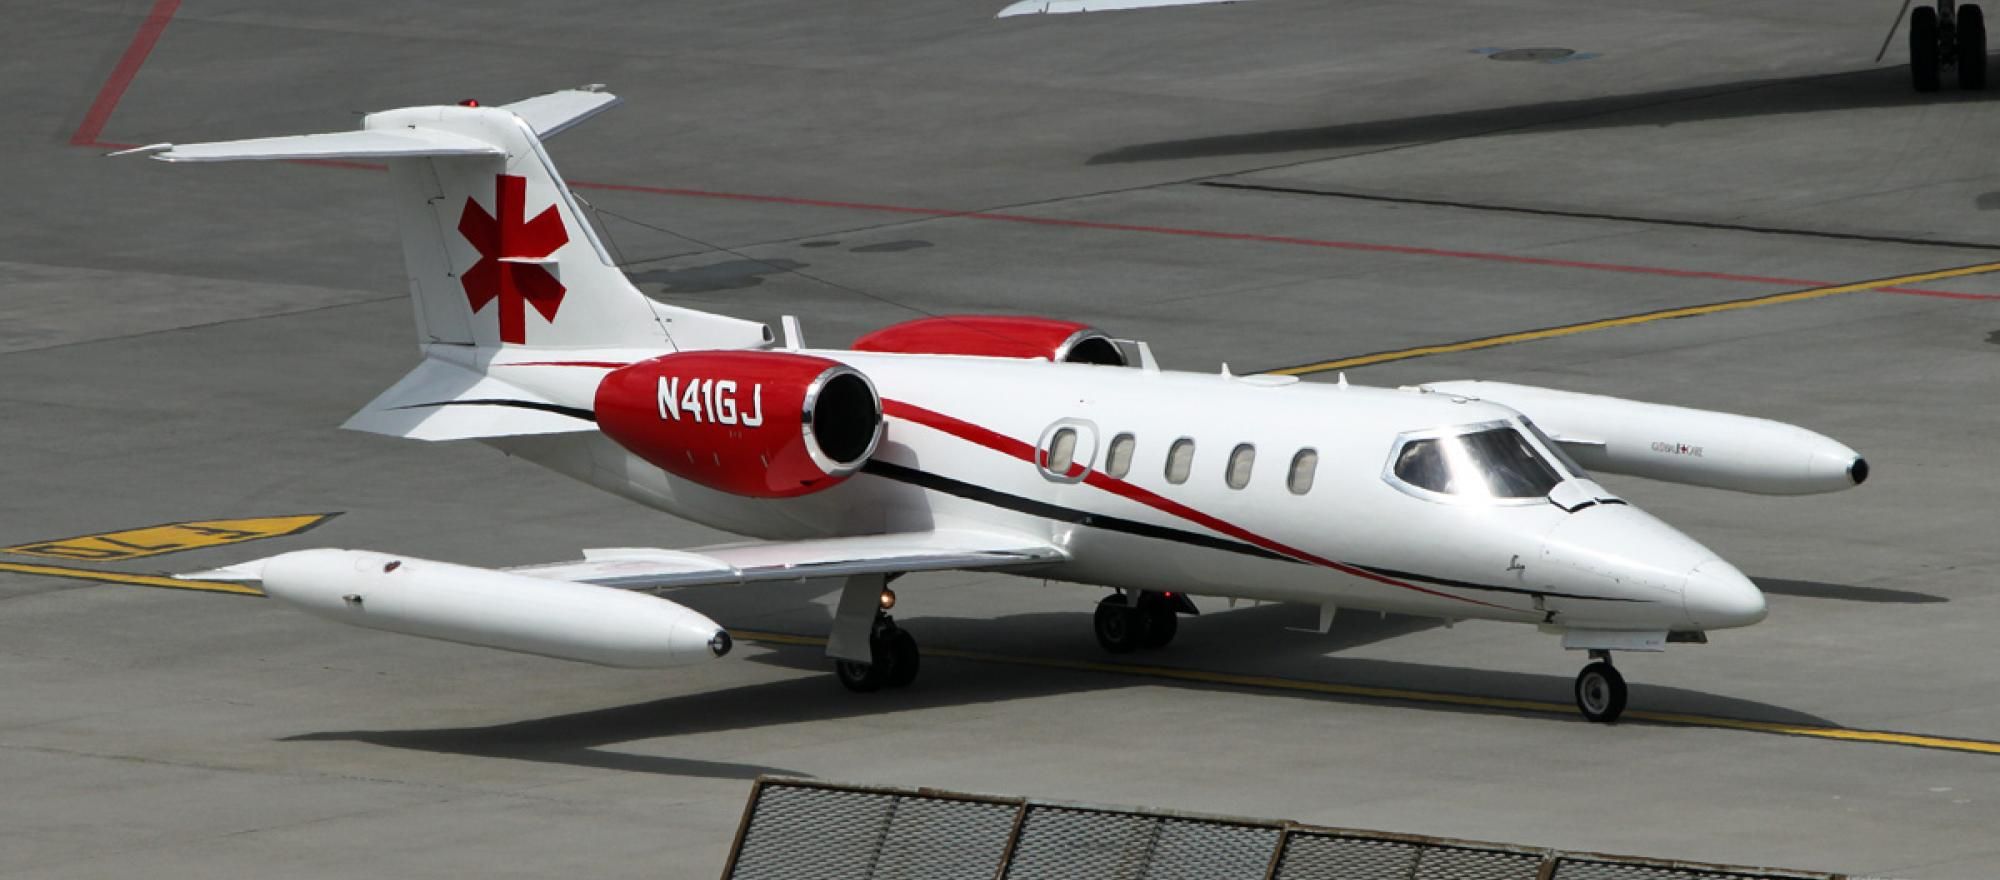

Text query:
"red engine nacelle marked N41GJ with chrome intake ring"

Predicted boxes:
[[596, 352, 882, 498]]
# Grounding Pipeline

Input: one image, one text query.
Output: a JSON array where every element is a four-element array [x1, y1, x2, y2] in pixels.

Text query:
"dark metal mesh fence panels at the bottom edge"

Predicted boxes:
[[724, 778, 1848, 880]]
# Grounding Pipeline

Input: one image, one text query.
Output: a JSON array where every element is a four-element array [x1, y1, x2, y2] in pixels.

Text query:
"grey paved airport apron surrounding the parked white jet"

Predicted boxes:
[[0, 0, 2000, 878]]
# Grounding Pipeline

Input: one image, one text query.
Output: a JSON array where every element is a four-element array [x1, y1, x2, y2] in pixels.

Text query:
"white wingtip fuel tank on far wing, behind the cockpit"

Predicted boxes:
[[1418, 380, 1868, 496]]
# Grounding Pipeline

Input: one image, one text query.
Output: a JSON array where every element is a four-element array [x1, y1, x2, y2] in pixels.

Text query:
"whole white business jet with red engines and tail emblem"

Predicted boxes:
[[130, 86, 1868, 722]]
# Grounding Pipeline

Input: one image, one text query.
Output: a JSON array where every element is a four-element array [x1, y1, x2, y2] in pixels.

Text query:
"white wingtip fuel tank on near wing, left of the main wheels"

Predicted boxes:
[[260, 550, 730, 668]]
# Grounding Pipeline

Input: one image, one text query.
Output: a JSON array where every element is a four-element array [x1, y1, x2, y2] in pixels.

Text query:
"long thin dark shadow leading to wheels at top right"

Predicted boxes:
[[1086, 66, 2000, 164]]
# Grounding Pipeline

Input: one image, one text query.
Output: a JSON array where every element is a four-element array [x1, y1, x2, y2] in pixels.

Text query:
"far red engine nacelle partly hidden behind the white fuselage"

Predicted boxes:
[[854, 314, 1126, 366]]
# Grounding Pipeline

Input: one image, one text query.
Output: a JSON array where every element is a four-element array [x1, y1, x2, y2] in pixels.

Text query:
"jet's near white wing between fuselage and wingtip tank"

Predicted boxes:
[[506, 530, 1068, 590]]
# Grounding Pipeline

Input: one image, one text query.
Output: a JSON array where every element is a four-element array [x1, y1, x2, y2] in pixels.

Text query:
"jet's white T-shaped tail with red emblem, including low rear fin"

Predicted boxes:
[[126, 86, 770, 440]]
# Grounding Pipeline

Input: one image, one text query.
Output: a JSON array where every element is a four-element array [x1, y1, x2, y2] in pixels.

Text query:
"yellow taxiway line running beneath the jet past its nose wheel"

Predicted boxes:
[[730, 630, 2000, 754]]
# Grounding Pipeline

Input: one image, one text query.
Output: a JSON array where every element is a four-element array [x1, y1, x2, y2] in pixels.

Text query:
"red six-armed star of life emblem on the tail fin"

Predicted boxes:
[[458, 174, 570, 344]]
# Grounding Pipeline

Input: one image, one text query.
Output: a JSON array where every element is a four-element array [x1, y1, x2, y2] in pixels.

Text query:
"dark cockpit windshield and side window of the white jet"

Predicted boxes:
[[1392, 426, 1562, 500]]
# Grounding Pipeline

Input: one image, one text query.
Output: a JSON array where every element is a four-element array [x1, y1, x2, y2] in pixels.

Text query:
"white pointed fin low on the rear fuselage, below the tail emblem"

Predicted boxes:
[[342, 358, 598, 440]]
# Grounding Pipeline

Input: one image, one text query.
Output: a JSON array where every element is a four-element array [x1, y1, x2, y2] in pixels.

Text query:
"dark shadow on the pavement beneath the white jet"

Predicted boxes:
[[286, 606, 1832, 778]]
